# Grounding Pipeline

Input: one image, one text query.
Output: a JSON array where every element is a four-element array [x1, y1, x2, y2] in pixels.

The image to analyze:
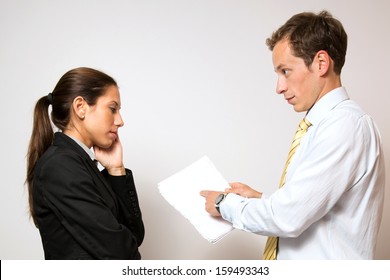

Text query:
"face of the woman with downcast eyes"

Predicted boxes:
[[82, 86, 124, 149]]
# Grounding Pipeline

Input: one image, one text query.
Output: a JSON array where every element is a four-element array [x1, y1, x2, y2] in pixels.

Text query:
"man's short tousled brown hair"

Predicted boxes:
[[266, 11, 348, 75]]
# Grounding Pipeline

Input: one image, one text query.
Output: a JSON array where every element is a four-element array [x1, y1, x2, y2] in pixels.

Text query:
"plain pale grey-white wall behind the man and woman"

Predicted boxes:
[[0, 0, 390, 260]]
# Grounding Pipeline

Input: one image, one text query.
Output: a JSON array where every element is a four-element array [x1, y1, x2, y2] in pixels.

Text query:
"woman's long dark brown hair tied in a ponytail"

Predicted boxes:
[[26, 67, 117, 225]]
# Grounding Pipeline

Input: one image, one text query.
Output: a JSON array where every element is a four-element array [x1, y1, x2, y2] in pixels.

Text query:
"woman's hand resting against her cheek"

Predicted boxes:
[[93, 136, 126, 176]]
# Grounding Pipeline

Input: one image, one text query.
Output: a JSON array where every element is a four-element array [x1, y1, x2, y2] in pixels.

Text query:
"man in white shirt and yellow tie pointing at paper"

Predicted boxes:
[[201, 11, 385, 259]]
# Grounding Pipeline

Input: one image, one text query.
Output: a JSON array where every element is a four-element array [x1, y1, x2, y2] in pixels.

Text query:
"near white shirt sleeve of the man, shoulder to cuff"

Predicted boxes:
[[220, 112, 369, 237]]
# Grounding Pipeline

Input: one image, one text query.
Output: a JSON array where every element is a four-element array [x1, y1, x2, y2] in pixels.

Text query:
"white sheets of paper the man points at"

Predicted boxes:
[[158, 156, 233, 243]]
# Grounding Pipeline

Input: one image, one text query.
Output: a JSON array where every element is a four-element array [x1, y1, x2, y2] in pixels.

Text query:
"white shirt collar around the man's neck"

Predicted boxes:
[[306, 87, 349, 125]]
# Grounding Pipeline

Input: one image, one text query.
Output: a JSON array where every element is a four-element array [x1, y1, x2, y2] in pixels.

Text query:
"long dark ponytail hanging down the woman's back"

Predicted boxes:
[[26, 96, 54, 226]]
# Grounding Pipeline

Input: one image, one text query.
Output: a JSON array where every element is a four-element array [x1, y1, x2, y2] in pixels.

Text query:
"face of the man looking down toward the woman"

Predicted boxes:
[[272, 40, 322, 112]]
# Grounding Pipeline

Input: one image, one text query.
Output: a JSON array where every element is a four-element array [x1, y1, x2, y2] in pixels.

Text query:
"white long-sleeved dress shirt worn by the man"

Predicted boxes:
[[220, 87, 385, 259]]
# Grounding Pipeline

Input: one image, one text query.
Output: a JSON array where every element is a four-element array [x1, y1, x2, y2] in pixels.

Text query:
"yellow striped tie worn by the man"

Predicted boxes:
[[263, 119, 311, 260]]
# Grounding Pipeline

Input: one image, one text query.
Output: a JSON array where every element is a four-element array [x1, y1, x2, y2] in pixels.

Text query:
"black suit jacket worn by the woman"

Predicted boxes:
[[33, 133, 144, 259]]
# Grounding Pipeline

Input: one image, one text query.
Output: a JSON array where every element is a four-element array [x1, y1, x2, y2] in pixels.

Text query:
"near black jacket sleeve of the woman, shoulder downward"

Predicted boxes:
[[39, 153, 143, 259]]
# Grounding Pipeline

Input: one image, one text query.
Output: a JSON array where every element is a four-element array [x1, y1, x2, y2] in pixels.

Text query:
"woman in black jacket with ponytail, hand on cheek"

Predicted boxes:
[[26, 68, 144, 259]]
